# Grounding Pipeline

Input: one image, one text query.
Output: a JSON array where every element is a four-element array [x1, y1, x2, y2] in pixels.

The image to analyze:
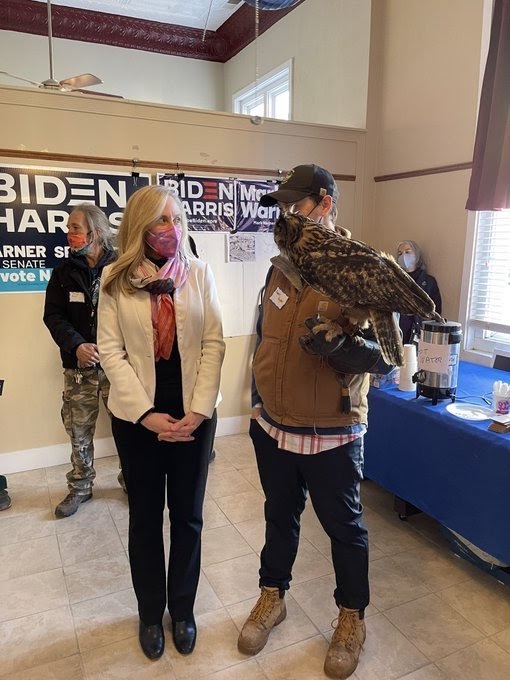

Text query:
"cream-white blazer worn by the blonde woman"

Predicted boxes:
[[97, 259, 225, 423]]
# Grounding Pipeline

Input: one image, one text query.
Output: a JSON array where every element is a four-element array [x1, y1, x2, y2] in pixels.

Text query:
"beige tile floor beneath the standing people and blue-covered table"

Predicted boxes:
[[0, 435, 510, 680]]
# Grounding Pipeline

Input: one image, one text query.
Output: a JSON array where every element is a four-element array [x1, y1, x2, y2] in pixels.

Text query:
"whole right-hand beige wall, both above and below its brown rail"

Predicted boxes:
[[363, 0, 484, 326]]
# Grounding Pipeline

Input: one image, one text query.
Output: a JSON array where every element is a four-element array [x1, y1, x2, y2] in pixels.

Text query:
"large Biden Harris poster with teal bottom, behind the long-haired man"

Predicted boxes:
[[0, 166, 150, 293]]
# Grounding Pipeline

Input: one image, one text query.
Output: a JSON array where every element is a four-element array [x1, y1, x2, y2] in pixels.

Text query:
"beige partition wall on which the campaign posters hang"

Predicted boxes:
[[0, 87, 365, 472]]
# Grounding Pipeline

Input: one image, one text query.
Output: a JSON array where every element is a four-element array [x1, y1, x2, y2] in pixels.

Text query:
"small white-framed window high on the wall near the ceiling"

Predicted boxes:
[[232, 59, 292, 120]]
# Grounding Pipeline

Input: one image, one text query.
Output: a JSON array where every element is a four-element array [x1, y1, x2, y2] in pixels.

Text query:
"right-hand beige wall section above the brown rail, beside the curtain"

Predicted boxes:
[[378, 0, 483, 174]]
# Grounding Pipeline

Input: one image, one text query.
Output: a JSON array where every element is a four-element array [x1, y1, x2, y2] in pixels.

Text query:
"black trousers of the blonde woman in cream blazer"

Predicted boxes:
[[112, 415, 216, 626]]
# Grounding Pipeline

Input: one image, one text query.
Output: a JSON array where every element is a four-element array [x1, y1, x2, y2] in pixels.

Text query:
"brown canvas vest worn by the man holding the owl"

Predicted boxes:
[[253, 266, 369, 428]]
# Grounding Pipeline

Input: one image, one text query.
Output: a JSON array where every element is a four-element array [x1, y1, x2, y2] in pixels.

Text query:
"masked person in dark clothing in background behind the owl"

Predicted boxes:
[[397, 240, 442, 344]]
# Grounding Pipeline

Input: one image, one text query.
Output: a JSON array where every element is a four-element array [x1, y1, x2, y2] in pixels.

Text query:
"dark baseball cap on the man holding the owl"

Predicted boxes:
[[260, 165, 338, 207]]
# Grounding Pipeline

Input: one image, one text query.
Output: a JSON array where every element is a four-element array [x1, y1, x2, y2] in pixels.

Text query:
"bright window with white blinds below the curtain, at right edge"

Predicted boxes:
[[461, 210, 510, 366]]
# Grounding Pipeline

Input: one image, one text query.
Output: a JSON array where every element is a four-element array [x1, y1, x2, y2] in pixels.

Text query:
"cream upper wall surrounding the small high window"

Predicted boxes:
[[224, 0, 371, 128]]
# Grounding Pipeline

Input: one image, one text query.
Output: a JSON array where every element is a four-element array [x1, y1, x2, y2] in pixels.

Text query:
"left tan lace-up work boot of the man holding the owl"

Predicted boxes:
[[237, 586, 287, 654]]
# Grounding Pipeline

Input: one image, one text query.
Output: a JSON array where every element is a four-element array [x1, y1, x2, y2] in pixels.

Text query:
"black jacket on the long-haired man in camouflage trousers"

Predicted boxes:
[[43, 251, 115, 368]]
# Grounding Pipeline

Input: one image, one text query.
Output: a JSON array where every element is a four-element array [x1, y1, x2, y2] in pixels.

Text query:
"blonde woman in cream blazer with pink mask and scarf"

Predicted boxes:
[[98, 186, 225, 660]]
